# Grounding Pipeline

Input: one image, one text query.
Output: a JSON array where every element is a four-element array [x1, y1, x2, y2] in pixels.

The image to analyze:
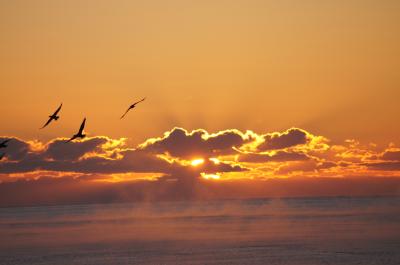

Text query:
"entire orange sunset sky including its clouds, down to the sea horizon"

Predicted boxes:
[[0, 0, 400, 205]]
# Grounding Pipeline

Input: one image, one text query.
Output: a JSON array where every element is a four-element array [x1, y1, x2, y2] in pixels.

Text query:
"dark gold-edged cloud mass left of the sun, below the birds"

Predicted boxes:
[[0, 136, 159, 173]]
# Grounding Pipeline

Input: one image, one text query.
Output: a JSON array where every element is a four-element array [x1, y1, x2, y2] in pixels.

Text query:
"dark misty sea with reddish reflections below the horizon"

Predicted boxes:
[[0, 198, 400, 265]]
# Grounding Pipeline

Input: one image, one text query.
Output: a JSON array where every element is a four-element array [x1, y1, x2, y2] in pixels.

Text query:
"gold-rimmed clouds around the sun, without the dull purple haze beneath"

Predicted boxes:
[[0, 128, 400, 181]]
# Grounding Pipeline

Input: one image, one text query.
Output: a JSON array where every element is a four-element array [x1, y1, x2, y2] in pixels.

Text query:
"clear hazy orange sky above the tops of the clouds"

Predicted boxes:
[[0, 0, 400, 144]]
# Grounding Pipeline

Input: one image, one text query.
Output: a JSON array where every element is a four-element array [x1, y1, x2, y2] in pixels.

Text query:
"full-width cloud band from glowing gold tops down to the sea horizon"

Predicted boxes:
[[0, 128, 400, 205]]
